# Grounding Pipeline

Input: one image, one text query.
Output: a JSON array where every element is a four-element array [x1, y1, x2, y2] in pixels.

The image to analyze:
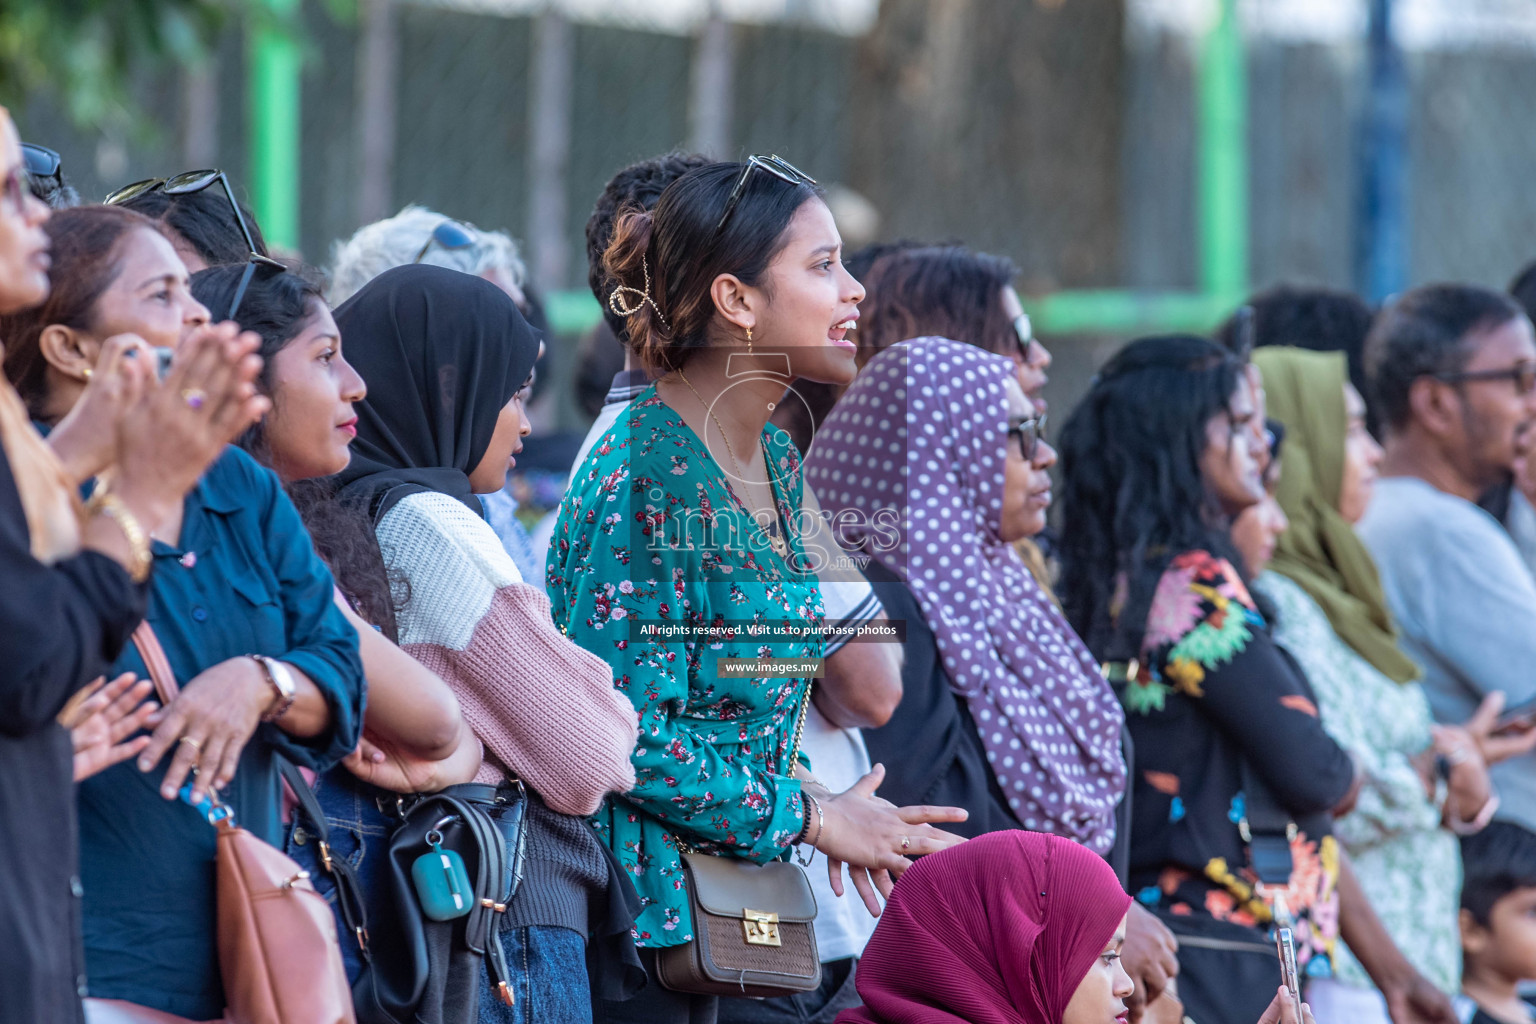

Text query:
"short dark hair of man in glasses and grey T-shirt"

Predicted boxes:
[[1366, 284, 1525, 430]]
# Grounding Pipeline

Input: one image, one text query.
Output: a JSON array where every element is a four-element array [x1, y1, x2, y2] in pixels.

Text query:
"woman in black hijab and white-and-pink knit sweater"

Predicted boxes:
[[327, 266, 636, 1021]]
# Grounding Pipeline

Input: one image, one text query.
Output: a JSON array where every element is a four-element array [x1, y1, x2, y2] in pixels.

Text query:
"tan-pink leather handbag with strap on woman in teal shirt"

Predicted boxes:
[[86, 622, 356, 1024]]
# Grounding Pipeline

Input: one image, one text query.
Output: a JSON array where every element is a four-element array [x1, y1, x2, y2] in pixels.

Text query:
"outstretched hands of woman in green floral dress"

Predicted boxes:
[[811, 765, 969, 917]]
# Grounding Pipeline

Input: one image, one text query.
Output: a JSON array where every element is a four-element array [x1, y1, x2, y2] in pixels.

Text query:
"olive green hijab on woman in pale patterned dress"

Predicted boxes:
[[1253, 347, 1419, 683]]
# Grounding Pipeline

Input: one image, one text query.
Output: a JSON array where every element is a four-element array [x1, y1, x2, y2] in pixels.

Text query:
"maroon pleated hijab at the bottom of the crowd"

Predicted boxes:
[[837, 831, 1130, 1024]]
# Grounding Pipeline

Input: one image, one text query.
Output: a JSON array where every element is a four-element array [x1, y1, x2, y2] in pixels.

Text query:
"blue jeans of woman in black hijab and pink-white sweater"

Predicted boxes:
[[481, 927, 591, 1024]]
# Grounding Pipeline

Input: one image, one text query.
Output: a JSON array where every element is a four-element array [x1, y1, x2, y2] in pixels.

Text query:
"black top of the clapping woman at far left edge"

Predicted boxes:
[[0, 450, 146, 1024]]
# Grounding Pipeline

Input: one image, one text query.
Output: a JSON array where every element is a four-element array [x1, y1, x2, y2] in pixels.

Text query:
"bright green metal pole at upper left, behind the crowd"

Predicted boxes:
[[247, 0, 301, 250]]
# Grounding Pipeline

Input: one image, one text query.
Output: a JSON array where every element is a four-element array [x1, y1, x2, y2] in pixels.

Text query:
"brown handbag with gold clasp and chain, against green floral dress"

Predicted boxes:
[[656, 680, 822, 998]]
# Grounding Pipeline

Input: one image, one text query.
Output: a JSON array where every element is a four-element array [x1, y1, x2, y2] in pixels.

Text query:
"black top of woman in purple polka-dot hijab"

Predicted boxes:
[[863, 559, 1023, 838]]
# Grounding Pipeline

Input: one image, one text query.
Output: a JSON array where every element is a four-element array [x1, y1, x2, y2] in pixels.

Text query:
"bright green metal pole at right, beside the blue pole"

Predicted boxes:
[[1197, 0, 1249, 296]]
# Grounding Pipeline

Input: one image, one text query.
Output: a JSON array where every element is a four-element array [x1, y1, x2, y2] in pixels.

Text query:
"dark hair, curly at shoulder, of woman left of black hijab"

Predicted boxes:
[[192, 264, 401, 640]]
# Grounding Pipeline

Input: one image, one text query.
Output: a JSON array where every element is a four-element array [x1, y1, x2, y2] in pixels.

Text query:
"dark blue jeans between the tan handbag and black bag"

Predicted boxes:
[[284, 768, 396, 983]]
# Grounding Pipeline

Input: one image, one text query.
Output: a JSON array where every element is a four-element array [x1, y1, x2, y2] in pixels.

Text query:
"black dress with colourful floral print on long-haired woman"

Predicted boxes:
[[1121, 551, 1355, 976]]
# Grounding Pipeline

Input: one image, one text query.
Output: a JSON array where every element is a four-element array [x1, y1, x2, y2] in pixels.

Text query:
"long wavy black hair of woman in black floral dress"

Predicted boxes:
[[1057, 335, 1243, 660]]
